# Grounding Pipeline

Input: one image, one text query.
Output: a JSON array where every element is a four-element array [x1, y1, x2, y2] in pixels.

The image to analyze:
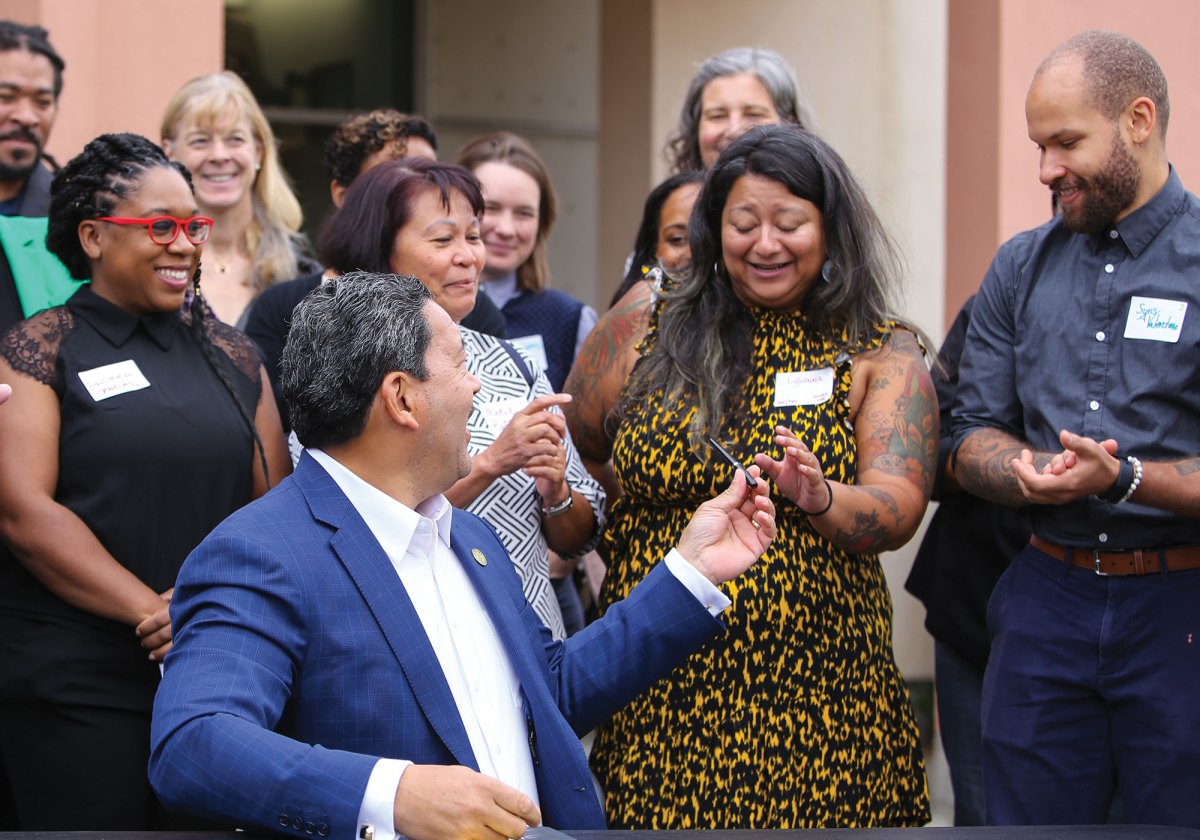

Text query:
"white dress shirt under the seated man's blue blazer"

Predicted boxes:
[[307, 449, 731, 840]]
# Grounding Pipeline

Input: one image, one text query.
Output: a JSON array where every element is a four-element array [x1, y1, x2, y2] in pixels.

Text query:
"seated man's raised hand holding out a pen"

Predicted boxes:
[[678, 467, 775, 583]]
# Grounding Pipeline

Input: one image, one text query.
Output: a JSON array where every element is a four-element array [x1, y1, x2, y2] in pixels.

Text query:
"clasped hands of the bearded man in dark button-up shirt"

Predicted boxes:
[[1013, 430, 1121, 504]]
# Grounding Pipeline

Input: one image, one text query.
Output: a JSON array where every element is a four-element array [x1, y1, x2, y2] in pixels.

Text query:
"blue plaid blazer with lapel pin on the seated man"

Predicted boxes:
[[150, 456, 722, 839]]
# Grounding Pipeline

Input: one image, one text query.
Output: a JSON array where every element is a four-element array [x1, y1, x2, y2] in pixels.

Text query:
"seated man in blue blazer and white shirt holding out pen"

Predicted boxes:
[[150, 274, 775, 840]]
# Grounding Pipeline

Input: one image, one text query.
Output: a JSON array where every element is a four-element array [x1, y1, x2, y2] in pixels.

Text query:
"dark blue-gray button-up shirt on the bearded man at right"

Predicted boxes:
[[953, 169, 1200, 550]]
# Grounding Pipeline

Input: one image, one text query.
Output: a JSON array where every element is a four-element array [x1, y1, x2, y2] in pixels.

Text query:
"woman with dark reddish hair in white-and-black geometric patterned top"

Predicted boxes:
[[301, 158, 605, 638]]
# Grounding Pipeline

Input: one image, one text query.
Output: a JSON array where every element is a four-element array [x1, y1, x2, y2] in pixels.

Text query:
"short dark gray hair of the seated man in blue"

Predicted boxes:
[[280, 271, 433, 449]]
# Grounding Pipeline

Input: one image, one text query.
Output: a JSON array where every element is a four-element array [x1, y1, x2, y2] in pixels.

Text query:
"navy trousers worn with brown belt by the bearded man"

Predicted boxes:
[[983, 546, 1200, 828]]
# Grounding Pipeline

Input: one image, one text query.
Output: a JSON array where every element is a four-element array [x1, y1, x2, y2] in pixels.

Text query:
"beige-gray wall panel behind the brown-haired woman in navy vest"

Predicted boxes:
[[419, 0, 600, 304]]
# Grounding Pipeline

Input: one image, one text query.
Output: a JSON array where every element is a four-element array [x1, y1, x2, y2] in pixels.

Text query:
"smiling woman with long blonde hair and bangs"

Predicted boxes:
[[162, 71, 319, 328]]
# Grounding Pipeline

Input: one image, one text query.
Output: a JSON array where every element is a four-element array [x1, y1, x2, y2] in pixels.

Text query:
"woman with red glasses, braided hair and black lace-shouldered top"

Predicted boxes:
[[0, 134, 290, 830]]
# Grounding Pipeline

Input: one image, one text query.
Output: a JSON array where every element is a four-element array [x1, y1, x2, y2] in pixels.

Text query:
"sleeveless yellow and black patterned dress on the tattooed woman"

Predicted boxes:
[[592, 310, 929, 829]]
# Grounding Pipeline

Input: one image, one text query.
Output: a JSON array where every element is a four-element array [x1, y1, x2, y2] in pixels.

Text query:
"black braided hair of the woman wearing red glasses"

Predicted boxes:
[[46, 134, 270, 486]]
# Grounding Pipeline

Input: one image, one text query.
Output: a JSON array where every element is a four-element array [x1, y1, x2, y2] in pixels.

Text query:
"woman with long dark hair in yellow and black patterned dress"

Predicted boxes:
[[592, 126, 937, 829]]
